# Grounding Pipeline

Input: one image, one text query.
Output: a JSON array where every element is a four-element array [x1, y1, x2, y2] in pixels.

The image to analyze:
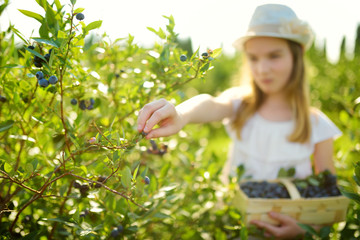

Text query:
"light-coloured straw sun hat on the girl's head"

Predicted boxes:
[[233, 4, 313, 50]]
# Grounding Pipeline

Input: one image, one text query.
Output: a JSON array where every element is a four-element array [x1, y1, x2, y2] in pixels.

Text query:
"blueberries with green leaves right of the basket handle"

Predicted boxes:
[[294, 171, 341, 198]]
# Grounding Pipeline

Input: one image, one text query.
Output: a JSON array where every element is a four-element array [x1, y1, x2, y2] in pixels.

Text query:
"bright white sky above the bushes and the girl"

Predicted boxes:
[[0, 0, 360, 60]]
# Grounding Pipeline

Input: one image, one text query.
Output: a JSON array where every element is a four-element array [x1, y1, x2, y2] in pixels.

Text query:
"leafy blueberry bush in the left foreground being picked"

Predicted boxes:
[[0, 0, 228, 239]]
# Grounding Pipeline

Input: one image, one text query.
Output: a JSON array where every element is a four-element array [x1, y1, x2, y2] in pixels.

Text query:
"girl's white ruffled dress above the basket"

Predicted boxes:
[[224, 99, 341, 180]]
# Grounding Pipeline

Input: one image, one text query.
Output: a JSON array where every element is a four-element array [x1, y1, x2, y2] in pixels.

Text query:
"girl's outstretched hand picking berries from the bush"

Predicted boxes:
[[137, 99, 185, 139]]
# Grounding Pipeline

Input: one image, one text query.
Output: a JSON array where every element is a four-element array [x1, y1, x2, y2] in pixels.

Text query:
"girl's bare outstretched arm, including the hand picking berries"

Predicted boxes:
[[138, 94, 233, 139]]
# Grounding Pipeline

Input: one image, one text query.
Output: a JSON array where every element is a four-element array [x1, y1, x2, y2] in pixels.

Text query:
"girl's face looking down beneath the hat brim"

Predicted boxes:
[[244, 37, 293, 95]]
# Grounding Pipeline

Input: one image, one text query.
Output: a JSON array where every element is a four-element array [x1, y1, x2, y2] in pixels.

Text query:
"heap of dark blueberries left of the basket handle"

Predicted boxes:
[[240, 181, 290, 198]]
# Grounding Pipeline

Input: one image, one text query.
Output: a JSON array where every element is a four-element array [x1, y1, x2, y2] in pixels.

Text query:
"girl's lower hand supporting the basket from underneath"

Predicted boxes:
[[251, 212, 305, 239]]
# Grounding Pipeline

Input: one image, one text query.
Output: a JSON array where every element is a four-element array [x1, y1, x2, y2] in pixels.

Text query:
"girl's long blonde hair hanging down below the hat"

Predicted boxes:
[[232, 40, 311, 143]]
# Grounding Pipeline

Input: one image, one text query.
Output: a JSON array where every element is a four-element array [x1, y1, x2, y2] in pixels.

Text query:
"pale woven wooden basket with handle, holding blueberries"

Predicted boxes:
[[233, 179, 350, 225]]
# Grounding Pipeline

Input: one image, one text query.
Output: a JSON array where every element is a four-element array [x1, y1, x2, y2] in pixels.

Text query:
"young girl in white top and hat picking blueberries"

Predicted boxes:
[[138, 4, 341, 239]]
